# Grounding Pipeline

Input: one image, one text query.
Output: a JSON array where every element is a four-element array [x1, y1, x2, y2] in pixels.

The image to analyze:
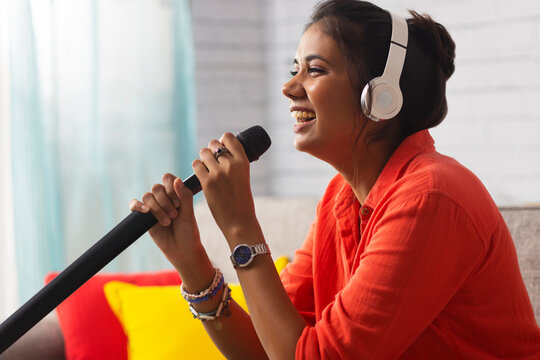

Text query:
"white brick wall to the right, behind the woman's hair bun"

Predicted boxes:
[[381, 0, 540, 205]]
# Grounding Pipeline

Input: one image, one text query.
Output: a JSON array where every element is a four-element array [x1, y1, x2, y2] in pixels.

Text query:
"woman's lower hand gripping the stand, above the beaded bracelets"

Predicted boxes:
[[130, 174, 202, 269]]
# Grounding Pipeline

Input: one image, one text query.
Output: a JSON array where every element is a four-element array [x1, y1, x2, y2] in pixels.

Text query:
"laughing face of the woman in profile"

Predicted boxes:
[[282, 23, 361, 165]]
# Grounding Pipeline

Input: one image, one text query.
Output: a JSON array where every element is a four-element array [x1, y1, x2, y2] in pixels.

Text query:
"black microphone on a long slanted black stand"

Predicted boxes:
[[0, 125, 271, 354]]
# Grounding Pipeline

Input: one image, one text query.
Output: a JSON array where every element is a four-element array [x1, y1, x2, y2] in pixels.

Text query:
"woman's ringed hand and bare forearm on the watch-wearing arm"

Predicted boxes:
[[186, 133, 306, 359]]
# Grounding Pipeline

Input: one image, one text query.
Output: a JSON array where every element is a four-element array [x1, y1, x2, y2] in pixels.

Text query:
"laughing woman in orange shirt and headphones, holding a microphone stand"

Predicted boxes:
[[131, 0, 540, 359]]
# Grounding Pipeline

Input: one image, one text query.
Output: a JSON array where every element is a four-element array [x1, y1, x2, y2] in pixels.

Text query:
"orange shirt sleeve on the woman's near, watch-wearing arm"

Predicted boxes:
[[296, 193, 486, 359]]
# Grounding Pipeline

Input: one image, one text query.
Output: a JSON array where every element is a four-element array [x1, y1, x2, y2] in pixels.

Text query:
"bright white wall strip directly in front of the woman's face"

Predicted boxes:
[[265, 0, 335, 197]]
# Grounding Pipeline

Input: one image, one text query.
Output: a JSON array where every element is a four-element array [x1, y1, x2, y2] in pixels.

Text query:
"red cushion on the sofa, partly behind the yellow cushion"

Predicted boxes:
[[45, 271, 180, 360]]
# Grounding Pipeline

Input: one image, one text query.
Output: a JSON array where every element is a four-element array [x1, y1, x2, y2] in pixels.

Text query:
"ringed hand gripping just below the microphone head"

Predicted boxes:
[[192, 133, 258, 239]]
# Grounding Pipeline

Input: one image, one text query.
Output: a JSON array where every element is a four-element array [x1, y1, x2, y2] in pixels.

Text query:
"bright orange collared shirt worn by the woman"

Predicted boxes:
[[282, 130, 540, 360]]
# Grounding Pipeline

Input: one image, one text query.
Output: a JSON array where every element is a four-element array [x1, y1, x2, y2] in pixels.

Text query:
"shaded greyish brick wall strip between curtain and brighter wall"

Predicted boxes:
[[191, 0, 272, 194]]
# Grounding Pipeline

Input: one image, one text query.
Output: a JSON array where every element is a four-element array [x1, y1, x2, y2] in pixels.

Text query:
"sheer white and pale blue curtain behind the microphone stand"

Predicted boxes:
[[10, 0, 196, 301]]
